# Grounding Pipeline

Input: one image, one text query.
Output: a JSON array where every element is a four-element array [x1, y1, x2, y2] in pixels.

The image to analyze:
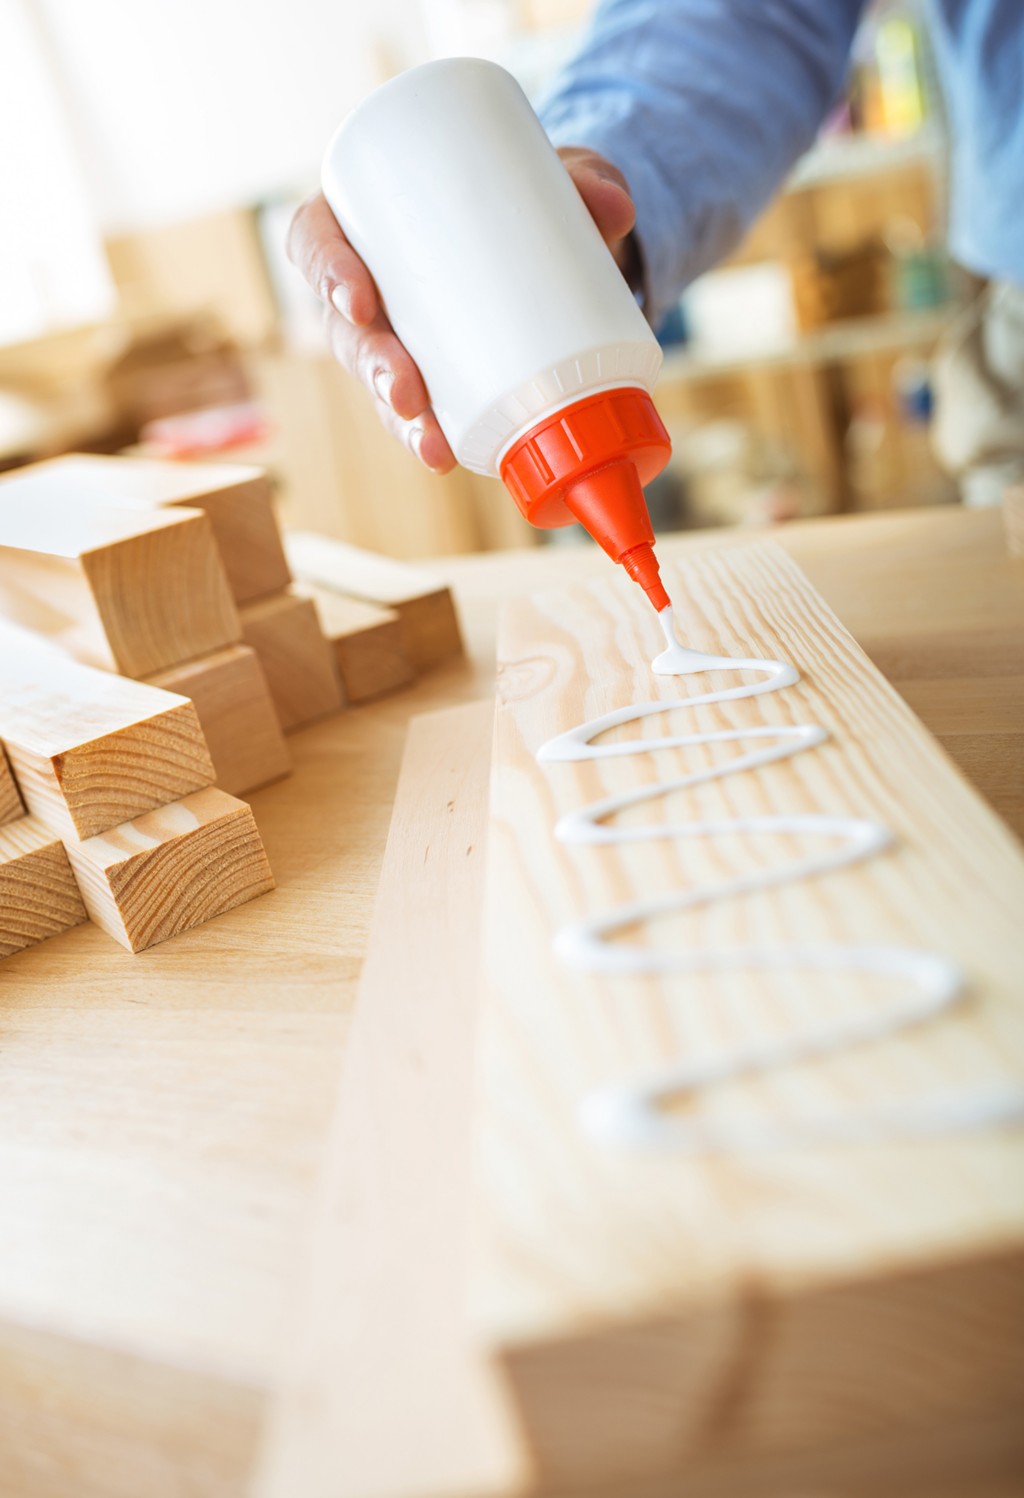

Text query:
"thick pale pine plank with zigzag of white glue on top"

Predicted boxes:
[[473, 545, 1024, 1491]]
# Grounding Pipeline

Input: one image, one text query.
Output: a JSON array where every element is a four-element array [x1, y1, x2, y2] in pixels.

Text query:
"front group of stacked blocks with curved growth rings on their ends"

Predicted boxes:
[[0, 625, 274, 956]]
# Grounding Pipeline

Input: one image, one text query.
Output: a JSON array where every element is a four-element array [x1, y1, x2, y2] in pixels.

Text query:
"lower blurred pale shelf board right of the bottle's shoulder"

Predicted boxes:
[[660, 303, 960, 382]]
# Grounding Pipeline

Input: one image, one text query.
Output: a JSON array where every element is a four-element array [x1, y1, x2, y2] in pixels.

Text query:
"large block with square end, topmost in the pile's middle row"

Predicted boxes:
[[0, 491, 241, 677]]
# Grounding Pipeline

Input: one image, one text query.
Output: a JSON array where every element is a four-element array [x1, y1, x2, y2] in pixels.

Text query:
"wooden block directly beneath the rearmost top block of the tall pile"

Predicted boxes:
[[241, 593, 344, 733]]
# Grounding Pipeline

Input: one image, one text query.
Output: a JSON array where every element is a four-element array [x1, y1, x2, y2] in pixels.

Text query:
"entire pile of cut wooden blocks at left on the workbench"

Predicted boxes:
[[0, 454, 461, 956]]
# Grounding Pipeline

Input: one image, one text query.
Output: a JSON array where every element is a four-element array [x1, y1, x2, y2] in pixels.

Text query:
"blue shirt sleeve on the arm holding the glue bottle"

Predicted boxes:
[[540, 0, 865, 324]]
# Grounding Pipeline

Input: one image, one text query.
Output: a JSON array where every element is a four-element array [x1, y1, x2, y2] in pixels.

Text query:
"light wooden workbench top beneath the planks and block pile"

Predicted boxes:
[[0, 511, 1024, 1498]]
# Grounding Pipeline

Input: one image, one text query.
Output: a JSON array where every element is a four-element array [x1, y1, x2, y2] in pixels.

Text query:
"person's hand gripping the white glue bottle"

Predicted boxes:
[[287, 145, 635, 473]]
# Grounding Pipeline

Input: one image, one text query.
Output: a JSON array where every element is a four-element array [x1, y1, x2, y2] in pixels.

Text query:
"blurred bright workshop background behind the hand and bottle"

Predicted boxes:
[[0, 0, 970, 557]]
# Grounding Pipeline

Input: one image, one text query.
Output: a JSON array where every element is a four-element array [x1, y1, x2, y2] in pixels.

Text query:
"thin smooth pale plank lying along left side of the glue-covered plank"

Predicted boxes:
[[257, 703, 511, 1498]]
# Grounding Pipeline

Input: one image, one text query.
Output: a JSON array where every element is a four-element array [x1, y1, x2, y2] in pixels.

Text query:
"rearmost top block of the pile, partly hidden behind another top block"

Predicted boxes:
[[0, 452, 292, 604]]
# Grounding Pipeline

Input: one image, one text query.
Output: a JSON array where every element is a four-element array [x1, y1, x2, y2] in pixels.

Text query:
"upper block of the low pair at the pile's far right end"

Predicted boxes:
[[284, 530, 463, 670]]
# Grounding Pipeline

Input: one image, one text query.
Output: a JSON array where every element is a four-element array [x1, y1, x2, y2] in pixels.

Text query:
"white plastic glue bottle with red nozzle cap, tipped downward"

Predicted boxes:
[[323, 58, 671, 611]]
